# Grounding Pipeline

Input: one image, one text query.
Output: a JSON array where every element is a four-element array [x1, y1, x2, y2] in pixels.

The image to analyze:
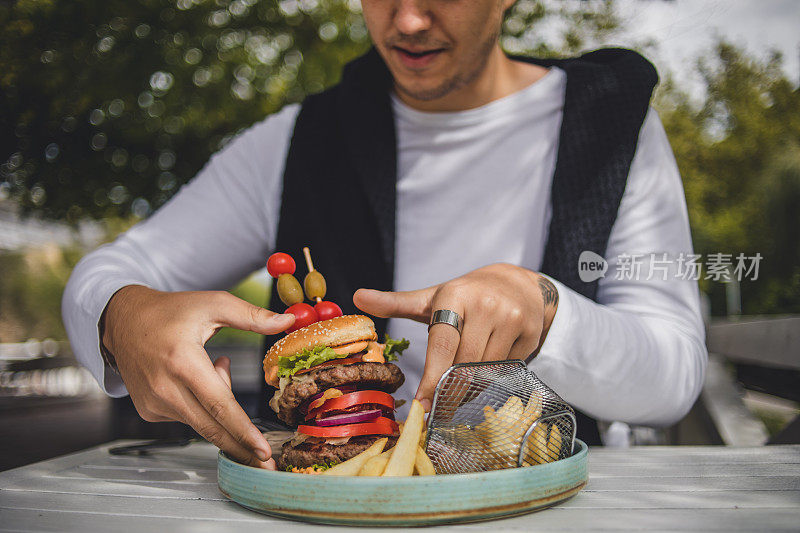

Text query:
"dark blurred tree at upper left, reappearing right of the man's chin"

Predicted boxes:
[[0, 0, 617, 222]]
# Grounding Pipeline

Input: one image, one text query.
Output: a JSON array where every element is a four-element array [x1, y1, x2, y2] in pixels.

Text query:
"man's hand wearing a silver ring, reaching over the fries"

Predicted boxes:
[[353, 264, 558, 410]]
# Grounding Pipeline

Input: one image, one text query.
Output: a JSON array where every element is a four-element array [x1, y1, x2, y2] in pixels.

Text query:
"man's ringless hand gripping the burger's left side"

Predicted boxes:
[[102, 285, 294, 470]]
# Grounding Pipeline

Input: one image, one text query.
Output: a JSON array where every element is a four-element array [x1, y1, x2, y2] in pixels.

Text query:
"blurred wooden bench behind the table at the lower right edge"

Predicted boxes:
[[670, 316, 800, 446]]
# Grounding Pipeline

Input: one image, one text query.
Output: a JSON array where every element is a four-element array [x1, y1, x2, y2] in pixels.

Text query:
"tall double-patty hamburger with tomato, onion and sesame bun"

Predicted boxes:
[[264, 315, 408, 473]]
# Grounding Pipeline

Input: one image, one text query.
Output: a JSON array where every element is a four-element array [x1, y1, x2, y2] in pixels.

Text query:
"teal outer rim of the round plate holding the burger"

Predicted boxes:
[[217, 439, 588, 526]]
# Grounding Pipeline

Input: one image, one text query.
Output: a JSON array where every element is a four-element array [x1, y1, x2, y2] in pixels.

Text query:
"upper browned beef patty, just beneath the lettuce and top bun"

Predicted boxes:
[[277, 363, 405, 426]]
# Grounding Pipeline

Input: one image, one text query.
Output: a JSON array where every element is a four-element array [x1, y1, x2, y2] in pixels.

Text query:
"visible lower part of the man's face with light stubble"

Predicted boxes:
[[361, 0, 513, 101]]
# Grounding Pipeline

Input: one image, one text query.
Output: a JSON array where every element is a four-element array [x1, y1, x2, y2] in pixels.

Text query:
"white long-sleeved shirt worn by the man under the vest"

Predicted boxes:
[[62, 68, 707, 425]]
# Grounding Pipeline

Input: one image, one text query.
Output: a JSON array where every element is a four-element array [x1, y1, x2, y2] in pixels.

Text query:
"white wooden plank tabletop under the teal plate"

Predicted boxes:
[[0, 443, 800, 533]]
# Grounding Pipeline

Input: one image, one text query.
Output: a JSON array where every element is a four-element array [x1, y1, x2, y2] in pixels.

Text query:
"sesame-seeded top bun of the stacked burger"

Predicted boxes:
[[264, 315, 378, 382]]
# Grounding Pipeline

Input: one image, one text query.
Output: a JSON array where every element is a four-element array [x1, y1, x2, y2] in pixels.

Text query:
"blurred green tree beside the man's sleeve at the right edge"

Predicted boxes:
[[656, 41, 800, 314]]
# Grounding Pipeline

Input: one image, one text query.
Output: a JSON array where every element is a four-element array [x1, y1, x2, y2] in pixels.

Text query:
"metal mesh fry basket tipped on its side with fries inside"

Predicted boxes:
[[425, 360, 576, 474]]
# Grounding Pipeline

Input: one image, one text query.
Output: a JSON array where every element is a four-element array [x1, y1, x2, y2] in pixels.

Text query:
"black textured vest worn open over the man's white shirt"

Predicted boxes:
[[262, 49, 658, 444]]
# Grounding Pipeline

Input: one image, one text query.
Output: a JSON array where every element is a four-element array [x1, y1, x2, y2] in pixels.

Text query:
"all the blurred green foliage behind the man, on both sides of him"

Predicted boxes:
[[0, 0, 800, 340]]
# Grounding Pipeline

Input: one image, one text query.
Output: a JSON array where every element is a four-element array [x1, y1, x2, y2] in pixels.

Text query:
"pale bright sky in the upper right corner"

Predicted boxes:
[[615, 0, 800, 94]]
